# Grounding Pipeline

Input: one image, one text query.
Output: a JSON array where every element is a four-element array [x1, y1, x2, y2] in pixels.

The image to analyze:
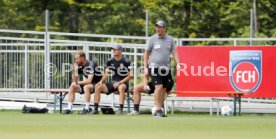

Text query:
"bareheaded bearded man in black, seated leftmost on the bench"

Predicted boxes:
[[64, 51, 102, 114]]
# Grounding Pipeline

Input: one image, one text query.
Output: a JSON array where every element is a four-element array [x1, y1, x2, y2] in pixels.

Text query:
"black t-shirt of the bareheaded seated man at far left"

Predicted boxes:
[[78, 61, 102, 84]]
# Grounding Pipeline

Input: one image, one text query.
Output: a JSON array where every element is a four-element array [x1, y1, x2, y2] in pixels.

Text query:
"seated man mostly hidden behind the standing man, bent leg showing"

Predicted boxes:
[[130, 73, 174, 115]]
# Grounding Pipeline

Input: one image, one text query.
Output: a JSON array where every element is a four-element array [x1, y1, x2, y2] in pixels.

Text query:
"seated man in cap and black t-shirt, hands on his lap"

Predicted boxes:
[[91, 45, 131, 115]]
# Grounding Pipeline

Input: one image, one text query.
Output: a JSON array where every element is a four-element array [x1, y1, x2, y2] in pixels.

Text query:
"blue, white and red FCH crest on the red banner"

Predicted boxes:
[[229, 50, 262, 93]]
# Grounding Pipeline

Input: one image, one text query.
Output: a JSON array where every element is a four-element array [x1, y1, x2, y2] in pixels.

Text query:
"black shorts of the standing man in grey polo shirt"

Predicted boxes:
[[149, 68, 173, 88]]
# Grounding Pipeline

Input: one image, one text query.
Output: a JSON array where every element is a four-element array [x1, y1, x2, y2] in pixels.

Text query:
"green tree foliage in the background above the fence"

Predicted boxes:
[[0, 0, 276, 38]]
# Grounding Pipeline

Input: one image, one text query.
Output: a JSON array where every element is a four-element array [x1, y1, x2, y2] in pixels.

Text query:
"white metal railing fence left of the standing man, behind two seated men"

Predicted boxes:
[[0, 30, 149, 91]]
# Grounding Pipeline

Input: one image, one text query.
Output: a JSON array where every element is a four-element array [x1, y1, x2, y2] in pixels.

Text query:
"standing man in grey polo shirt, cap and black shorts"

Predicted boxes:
[[144, 20, 179, 117]]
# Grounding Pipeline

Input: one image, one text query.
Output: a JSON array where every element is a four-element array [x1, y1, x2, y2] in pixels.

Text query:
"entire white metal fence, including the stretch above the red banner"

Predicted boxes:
[[0, 29, 276, 112]]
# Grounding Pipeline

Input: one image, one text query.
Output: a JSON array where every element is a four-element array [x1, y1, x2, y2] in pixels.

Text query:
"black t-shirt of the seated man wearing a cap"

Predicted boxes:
[[105, 57, 131, 82]]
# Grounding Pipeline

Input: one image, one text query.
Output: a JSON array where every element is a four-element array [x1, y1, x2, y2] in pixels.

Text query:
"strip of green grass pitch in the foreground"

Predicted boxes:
[[0, 111, 276, 139]]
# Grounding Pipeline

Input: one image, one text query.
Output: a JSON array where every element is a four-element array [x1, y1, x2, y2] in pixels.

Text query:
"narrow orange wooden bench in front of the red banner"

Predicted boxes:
[[167, 91, 246, 116]]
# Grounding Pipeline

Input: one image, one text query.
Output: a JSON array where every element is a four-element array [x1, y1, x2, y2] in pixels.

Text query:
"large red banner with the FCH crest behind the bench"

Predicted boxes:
[[176, 46, 276, 98]]
